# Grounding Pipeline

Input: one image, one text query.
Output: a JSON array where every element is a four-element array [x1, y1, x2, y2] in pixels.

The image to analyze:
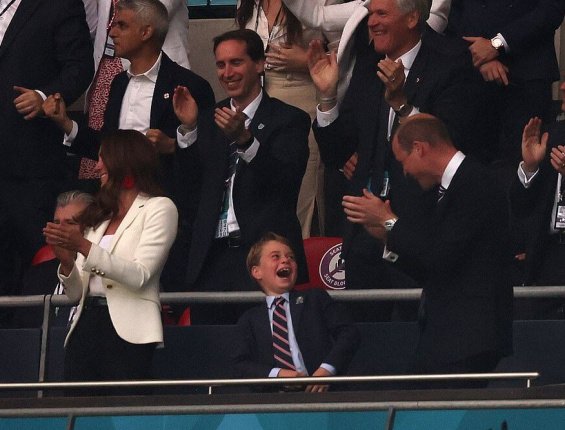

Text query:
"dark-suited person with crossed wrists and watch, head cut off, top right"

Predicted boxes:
[[447, 0, 565, 166]]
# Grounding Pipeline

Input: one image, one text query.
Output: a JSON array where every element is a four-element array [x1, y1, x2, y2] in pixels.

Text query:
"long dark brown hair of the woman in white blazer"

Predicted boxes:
[[78, 130, 163, 227]]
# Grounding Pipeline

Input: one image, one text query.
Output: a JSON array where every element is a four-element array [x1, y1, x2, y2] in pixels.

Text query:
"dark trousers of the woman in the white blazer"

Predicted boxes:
[[64, 300, 156, 396]]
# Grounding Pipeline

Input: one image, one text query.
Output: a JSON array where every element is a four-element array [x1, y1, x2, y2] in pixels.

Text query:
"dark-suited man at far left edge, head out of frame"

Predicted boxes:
[[0, 0, 93, 310]]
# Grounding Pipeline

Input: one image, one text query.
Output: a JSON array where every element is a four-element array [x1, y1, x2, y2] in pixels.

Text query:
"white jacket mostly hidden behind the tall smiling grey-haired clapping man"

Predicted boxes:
[[283, 0, 451, 102]]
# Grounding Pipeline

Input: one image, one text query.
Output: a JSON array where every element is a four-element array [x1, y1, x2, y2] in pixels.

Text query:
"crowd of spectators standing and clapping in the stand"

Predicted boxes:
[[0, 0, 565, 391]]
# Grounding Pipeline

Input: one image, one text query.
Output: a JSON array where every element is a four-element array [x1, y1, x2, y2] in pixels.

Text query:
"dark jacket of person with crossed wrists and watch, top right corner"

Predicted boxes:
[[447, 0, 565, 82]]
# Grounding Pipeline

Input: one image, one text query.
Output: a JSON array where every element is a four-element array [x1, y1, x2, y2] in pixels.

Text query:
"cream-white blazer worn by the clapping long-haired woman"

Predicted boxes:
[[59, 194, 178, 345]]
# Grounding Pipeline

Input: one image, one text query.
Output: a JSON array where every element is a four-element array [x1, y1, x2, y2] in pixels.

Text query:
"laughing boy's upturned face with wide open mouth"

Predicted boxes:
[[251, 240, 298, 296]]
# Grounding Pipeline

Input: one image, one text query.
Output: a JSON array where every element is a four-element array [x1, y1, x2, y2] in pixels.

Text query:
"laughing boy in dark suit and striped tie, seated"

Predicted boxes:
[[234, 233, 359, 392]]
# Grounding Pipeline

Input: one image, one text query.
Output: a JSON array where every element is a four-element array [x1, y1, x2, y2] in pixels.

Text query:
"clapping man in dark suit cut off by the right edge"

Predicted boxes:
[[510, 83, 565, 319]]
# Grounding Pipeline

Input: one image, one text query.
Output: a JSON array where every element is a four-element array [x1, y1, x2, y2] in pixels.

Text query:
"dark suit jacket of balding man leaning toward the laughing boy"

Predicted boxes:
[[387, 157, 512, 367]]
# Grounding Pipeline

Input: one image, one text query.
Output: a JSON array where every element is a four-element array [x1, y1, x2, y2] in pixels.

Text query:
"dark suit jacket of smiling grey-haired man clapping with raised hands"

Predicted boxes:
[[313, 20, 474, 283]]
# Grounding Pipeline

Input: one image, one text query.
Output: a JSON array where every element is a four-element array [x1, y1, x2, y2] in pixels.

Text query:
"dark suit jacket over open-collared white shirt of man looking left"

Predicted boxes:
[[71, 52, 215, 219]]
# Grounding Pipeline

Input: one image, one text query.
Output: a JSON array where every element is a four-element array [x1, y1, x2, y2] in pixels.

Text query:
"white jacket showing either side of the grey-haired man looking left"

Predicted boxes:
[[83, 0, 190, 107]]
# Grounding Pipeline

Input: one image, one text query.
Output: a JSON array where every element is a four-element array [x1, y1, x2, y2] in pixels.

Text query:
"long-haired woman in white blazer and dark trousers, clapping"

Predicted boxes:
[[44, 130, 178, 393]]
